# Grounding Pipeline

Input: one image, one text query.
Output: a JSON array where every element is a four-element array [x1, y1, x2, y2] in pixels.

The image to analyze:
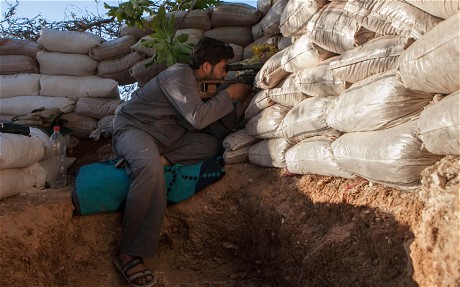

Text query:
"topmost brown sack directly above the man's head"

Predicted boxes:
[[211, 2, 262, 28]]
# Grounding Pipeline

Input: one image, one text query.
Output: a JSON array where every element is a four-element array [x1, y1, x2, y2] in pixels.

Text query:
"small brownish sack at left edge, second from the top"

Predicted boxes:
[[0, 55, 39, 75]]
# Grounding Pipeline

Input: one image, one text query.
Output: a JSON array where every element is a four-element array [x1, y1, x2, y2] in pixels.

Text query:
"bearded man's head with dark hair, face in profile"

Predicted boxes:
[[190, 37, 234, 80]]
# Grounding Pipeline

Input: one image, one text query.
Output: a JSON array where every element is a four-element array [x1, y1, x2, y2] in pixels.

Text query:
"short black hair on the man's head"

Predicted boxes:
[[189, 37, 234, 69]]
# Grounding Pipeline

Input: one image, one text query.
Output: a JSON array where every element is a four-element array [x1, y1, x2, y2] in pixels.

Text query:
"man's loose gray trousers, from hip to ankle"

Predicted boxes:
[[113, 129, 221, 258]]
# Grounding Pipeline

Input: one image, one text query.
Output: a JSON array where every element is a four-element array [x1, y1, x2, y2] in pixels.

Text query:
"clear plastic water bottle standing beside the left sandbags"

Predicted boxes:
[[49, 126, 67, 188]]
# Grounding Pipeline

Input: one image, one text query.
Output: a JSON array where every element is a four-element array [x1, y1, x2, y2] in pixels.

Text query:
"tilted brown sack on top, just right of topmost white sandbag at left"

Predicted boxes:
[[89, 35, 137, 61]]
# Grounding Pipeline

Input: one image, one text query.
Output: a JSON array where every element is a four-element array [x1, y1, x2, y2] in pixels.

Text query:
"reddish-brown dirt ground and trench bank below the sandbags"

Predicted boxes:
[[0, 138, 460, 287]]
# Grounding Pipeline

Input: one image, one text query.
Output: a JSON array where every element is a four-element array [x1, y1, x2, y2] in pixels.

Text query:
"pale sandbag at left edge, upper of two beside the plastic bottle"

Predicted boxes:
[[0, 133, 45, 169]]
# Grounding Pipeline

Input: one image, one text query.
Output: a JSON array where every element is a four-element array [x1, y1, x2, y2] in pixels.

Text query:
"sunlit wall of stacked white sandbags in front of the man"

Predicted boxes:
[[224, 0, 460, 189]]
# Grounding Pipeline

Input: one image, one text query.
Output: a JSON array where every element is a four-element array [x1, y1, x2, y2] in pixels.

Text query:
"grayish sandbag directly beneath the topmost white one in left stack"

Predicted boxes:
[[37, 51, 99, 76]]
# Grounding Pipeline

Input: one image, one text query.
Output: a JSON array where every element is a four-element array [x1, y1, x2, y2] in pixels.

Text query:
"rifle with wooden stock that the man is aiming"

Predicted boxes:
[[198, 63, 264, 100]]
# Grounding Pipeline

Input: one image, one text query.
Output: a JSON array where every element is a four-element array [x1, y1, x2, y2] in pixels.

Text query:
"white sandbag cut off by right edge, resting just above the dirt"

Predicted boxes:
[[418, 91, 460, 155]]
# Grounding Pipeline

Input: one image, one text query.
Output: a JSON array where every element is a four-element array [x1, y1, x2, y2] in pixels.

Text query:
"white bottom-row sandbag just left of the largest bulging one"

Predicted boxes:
[[285, 136, 355, 178]]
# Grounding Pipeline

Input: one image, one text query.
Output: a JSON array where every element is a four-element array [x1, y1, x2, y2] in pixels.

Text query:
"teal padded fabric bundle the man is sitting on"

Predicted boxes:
[[72, 159, 225, 215]]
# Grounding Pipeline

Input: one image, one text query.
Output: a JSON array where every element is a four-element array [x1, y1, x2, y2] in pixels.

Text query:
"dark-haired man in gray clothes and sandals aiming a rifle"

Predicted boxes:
[[113, 37, 253, 286]]
